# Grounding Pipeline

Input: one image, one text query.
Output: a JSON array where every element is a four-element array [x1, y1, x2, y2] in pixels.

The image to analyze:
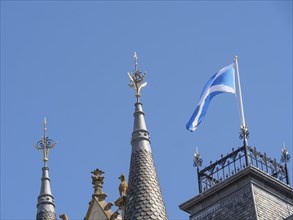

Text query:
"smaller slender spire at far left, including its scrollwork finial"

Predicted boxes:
[[34, 118, 56, 220]]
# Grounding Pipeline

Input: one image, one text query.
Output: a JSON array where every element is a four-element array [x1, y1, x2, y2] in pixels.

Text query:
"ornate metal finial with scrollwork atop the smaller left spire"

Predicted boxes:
[[34, 118, 56, 166]]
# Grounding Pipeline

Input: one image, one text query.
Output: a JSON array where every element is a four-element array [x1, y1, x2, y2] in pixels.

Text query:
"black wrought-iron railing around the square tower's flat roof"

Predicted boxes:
[[194, 146, 290, 193]]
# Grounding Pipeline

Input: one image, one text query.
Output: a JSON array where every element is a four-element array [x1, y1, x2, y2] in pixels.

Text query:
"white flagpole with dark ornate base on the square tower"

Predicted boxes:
[[234, 56, 249, 157]]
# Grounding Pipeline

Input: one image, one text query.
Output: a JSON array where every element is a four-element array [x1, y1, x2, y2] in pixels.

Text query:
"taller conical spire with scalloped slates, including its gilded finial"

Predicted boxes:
[[125, 54, 167, 220]]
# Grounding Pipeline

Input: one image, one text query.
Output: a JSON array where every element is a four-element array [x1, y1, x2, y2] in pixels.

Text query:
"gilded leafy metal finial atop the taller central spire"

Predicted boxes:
[[128, 52, 147, 102]]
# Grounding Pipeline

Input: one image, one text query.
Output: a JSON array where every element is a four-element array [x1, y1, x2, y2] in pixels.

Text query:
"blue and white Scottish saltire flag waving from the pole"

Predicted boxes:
[[186, 64, 236, 131]]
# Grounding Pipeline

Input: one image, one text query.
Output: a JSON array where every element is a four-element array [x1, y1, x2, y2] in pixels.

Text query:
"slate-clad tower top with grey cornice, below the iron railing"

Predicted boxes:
[[180, 166, 293, 220]]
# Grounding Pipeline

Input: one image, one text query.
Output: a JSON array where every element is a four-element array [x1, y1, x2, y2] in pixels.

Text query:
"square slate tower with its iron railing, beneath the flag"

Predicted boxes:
[[179, 146, 293, 220]]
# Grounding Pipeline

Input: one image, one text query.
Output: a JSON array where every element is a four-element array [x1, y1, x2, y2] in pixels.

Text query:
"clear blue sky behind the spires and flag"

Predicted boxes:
[[1, 1, 293, 219]]
